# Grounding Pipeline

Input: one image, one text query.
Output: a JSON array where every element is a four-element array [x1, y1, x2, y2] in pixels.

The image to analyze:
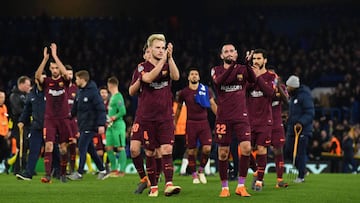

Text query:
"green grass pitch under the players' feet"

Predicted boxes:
[[0, 173, 360, 203]]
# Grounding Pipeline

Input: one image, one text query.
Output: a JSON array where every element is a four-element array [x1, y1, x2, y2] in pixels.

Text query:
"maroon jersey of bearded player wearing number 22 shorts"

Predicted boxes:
[[211, 64, 249, 121]]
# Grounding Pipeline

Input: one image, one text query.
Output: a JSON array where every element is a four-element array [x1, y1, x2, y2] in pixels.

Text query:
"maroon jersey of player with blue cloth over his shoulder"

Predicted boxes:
[[178, 87, 213, 121]]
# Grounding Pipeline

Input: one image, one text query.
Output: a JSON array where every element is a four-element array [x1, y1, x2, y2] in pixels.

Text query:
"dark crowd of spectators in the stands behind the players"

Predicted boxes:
[[0, 7, 360, 171]]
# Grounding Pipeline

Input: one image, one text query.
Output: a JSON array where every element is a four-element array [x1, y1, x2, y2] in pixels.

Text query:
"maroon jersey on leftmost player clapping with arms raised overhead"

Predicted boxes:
[[43, 77, 70, 119]]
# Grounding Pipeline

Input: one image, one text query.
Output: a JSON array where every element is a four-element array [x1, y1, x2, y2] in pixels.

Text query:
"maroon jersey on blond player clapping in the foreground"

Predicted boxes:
[[138, 62, 173, 121]]
